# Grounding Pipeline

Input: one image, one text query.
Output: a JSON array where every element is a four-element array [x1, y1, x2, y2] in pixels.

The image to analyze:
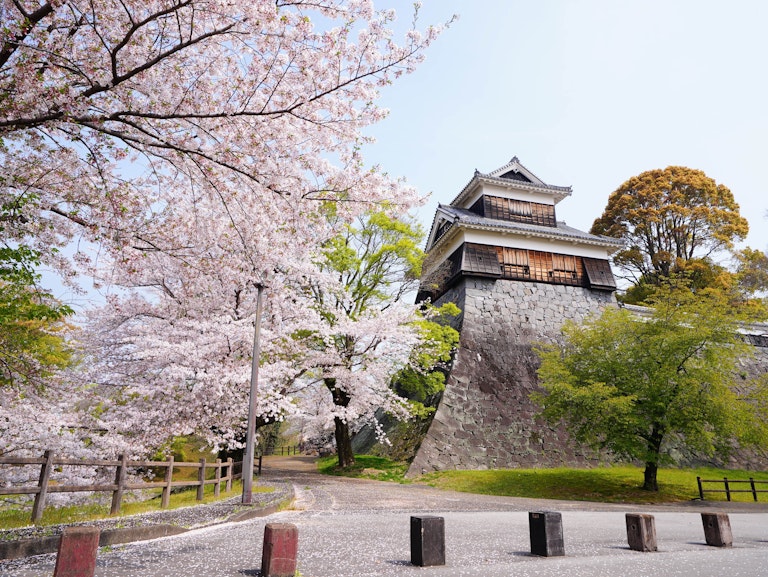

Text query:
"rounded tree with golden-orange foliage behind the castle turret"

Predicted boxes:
[[591, 166, 749, 285]]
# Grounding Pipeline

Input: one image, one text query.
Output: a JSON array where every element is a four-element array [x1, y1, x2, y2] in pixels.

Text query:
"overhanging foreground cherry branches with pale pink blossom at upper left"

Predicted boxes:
[[0, 0, 439, 284]]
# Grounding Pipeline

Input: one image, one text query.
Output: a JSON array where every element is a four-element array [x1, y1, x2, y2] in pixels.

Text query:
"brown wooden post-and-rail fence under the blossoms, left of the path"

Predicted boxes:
[[0, 451, 240, 523]]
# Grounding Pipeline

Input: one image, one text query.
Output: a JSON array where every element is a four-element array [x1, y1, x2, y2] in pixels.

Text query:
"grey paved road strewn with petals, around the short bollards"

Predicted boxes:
[[0, 460, 768, 577]]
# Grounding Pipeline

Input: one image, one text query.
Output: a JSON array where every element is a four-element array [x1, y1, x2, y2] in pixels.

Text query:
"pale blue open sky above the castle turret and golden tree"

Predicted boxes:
[[366, 0, 768, 250]]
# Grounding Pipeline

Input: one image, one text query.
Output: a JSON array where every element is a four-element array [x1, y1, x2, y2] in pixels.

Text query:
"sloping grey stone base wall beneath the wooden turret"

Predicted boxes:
[[408, 278, 616, 475]]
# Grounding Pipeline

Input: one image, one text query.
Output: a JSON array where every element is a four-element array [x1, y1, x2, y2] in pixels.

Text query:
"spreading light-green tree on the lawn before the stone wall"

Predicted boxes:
[[534, 286, 768, 491]]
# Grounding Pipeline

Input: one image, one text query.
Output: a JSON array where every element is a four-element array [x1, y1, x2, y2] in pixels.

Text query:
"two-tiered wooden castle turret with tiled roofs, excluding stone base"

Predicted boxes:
[[419, 157, 622, 300]]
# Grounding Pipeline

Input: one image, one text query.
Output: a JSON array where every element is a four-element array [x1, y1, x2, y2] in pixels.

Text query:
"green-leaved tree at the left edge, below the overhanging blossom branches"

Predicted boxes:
[[0, 246, 72, 390]]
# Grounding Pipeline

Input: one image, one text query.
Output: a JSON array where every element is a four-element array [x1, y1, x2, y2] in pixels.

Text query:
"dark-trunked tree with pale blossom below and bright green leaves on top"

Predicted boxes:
[[294, 211, 424, 467]]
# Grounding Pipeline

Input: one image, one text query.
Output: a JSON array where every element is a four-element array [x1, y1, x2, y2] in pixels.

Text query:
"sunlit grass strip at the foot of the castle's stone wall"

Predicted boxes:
[[318, 455, 768, 503]]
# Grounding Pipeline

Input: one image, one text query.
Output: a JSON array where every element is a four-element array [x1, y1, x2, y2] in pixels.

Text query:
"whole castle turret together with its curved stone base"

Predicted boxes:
[[409, 157, 622, 474]]
